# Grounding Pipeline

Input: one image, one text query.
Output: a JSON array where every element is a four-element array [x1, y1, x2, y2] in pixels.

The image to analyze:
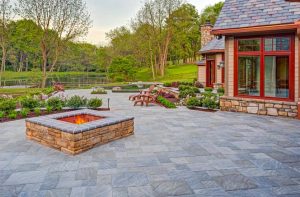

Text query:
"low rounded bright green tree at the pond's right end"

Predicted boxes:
[[108, 56, 137, 81]]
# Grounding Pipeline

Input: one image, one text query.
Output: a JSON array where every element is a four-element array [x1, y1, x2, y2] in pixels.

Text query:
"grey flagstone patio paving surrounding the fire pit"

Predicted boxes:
[[0, 90, 300, 197]]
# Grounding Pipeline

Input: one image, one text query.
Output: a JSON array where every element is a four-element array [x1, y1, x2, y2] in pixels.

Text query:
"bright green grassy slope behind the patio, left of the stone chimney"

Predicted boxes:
[[136, 64, 197, 82]]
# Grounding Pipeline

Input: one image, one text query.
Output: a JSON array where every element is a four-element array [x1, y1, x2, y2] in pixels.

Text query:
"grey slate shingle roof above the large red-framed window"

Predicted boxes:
[[214, 0, 300, 30]]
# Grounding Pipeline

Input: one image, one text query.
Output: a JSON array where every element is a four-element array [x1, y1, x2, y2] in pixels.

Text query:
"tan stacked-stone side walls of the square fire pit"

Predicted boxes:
[[26, 120, 134, 155]]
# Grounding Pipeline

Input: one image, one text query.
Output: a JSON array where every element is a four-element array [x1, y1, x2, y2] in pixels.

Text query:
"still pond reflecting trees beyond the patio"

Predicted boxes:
[[2, 73, 109, 88]]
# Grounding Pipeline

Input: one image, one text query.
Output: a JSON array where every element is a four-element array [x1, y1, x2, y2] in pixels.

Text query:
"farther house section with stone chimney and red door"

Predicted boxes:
[[197, 22, 225, 88]]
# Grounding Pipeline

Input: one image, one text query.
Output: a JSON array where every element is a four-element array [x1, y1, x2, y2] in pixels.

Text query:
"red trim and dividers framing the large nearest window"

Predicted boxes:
[[234, 34, 295, 102]]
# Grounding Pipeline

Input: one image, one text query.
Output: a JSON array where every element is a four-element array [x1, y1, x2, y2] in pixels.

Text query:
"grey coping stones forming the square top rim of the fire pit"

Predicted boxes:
[[26, 109, 134, 134]]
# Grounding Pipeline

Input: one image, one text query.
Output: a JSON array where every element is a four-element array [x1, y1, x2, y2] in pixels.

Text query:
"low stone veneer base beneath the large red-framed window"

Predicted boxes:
[[220, 96, 299, 118]]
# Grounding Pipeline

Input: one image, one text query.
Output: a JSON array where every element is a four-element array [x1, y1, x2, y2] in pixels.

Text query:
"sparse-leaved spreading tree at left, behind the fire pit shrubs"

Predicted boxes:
[[16, 0, 91, 88]]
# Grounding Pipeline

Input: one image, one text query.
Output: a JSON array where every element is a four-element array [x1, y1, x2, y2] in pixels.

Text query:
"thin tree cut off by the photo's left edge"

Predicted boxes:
[[0, 0, 13, 87]]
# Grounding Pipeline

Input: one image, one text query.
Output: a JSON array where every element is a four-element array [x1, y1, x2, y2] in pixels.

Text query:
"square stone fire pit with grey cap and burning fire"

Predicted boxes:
[[26, 110, 134, 155]]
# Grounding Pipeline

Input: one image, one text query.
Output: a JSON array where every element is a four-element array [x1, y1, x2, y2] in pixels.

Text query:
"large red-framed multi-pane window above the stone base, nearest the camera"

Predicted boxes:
[[235, 36, 295, 100]]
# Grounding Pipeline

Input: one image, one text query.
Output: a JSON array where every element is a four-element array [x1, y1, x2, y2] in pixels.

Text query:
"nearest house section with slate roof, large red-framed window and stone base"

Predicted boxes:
[[211, 0, 300, 118]]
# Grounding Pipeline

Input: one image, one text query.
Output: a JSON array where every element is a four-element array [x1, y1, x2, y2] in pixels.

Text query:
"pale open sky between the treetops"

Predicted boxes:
[[84, 0, 220, 45]]
